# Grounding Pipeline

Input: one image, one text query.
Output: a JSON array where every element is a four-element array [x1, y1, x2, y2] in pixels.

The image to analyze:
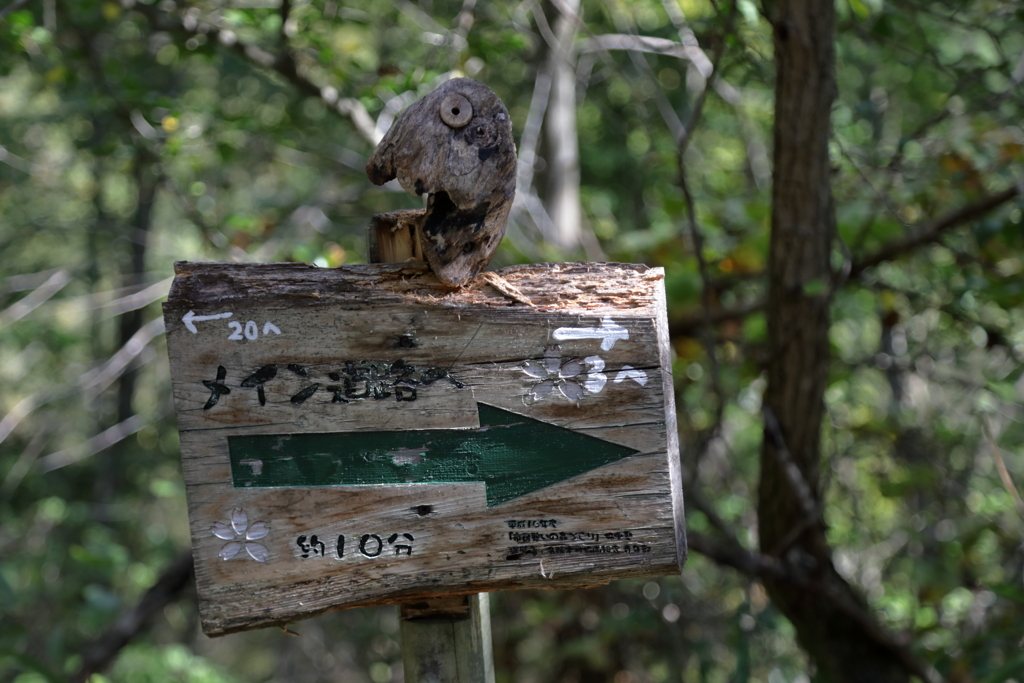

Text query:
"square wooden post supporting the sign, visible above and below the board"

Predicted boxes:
[[367, 210, 495, 683]]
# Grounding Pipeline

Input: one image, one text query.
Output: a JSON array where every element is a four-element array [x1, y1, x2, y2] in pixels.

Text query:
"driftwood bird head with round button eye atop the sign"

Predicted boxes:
[[367, 78, 516, 287]]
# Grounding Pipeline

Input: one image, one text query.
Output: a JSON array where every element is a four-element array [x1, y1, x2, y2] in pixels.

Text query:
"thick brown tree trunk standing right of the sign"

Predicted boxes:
[[758, 0, 909, 683]]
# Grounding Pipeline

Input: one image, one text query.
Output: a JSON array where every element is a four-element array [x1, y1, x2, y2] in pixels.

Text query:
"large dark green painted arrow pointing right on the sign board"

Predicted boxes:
[[227, 403, 639, 508]]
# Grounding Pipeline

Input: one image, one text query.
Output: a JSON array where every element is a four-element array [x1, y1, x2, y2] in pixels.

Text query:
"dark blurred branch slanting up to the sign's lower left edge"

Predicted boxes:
[[72, 549, 193, 683]]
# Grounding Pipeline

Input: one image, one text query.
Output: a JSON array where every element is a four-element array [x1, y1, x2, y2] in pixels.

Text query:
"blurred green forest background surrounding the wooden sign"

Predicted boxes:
[[0, 0, 1024, 683]]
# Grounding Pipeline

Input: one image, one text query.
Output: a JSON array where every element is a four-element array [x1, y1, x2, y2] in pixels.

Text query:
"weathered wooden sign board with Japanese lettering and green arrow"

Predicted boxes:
[[164, 263, 686, 635]]
